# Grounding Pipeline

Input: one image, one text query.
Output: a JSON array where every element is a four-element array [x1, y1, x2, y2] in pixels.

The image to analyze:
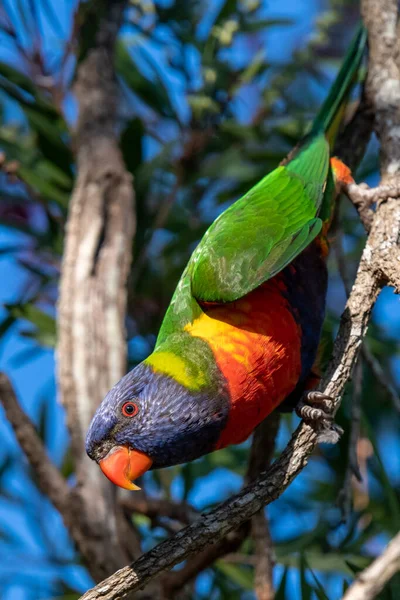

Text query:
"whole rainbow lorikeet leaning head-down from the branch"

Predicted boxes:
[[86, 28, 366, 489]]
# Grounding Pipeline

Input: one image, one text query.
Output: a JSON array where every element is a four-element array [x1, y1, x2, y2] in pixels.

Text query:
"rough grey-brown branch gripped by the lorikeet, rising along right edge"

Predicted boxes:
[[78, 0, 400, 600]]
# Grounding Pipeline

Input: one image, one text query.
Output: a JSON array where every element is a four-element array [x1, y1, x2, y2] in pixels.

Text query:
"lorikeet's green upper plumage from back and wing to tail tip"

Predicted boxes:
[[157, 27, 366, 332]]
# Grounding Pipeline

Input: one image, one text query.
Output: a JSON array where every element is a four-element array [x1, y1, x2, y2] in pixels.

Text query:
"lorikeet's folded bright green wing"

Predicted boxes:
[[188, 134, 329, 302]]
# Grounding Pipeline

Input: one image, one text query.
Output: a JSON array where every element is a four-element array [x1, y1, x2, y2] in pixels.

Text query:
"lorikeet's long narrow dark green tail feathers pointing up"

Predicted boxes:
[[307, 24, 367, 147]]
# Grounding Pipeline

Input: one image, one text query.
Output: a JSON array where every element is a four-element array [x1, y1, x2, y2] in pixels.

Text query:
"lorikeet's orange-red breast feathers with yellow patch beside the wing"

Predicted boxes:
[[185, 277, 301, 448]]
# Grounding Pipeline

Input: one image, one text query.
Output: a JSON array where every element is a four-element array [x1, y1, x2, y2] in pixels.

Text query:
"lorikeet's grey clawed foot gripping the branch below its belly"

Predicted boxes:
[[296, 390, 343, 444]]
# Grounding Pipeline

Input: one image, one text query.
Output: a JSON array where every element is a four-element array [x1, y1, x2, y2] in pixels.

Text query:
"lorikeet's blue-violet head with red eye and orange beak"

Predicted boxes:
[[86, 363, 228, 490]]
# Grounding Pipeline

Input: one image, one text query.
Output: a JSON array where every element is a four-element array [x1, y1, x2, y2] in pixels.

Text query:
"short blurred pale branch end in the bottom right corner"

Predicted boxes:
[[343, 533, 400, 600]]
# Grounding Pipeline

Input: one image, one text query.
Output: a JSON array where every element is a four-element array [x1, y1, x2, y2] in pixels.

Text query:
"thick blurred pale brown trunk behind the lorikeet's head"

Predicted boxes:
[[57, 0, 135, 580]]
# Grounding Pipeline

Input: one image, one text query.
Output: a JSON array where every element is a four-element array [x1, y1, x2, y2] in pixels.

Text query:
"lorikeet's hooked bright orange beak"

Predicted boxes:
[[99, 446, 153, 490]]
